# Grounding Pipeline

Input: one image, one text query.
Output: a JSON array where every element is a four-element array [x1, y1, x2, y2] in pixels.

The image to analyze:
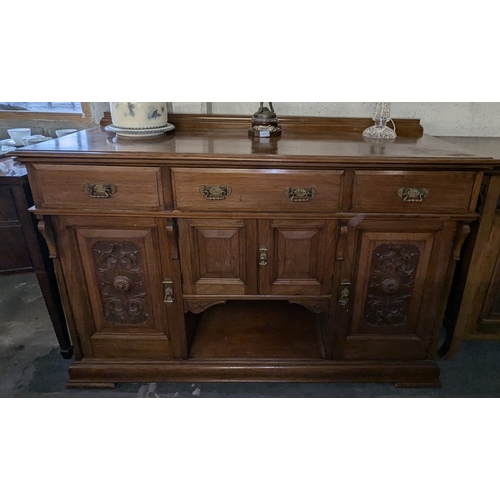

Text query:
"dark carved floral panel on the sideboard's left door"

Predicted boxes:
[[92, 241, 150, 325]]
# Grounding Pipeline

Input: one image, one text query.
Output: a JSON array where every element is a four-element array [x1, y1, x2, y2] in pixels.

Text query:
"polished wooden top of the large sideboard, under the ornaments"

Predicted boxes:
[[9, 115, 498, 168]]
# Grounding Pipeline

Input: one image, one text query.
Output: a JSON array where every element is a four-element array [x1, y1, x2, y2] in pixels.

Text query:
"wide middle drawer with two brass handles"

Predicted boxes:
[[172, 168, 344, 213]]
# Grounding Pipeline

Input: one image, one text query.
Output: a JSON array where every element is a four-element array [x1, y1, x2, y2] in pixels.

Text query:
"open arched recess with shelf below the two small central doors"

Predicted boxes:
[[189, 301, 325, 359]]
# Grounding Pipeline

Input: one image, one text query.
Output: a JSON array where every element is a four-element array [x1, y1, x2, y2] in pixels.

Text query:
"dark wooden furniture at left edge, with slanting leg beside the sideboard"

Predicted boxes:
[[0, 158, 73, 359]]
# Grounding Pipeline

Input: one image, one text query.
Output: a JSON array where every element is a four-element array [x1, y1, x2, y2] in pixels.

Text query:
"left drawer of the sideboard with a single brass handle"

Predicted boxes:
[[34, 165, 164, 210]]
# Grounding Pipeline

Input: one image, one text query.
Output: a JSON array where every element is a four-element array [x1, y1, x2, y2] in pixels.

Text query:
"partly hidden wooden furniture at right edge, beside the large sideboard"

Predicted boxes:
[[440, 137, 500, 359]]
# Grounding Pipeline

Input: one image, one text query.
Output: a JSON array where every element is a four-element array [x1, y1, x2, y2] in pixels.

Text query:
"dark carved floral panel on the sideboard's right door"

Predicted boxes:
[[364, 244, 420, 326]]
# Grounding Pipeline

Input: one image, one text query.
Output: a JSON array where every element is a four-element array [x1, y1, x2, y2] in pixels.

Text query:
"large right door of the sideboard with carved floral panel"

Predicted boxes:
[[332, 220, 455, 360]]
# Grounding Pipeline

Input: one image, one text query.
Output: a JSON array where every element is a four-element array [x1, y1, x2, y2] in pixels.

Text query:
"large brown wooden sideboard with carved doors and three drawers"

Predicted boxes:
[[10, 115, 498, 387]]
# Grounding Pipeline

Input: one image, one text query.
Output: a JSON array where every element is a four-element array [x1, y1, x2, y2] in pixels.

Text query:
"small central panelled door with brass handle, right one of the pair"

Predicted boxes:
[[259, 220, 337, 295]]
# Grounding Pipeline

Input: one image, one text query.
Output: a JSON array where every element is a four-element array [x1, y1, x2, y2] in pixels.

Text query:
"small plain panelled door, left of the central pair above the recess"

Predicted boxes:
[[179, 219, 257, 295]]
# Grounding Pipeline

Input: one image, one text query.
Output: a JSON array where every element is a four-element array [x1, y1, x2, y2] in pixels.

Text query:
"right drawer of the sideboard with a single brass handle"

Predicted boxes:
[[351, 170, 477, 214]]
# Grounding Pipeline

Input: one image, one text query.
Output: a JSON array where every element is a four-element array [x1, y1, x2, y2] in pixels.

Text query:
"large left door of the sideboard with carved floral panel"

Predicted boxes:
[[56, 217, 186, 359]]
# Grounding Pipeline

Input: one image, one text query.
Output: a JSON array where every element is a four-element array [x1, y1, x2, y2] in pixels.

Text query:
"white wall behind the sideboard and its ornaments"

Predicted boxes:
[[172, 102, 500, 137]]
